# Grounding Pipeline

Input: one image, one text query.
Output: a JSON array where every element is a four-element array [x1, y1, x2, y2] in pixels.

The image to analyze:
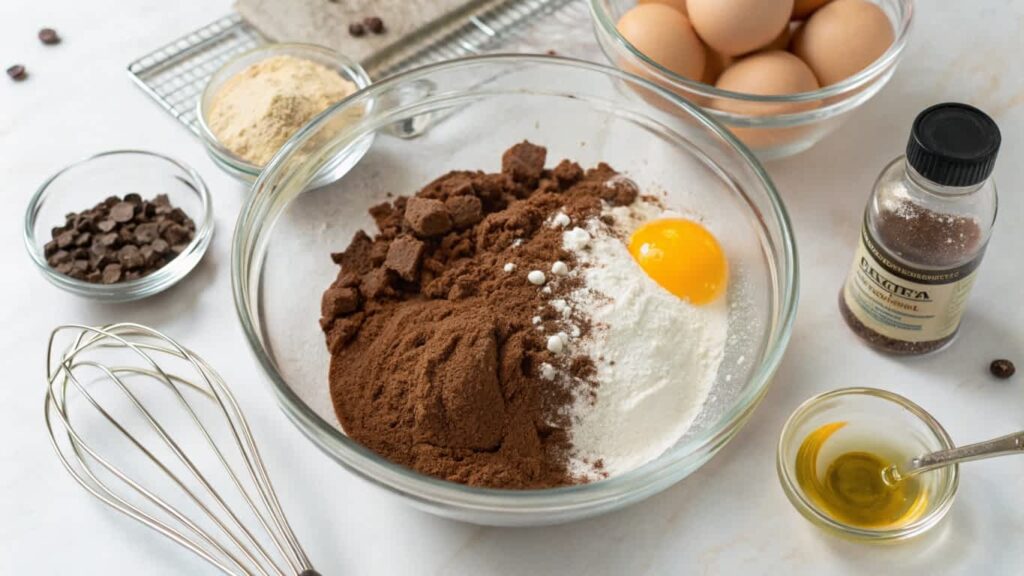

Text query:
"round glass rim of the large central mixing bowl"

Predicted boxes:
[[231, 54, 800, 513]]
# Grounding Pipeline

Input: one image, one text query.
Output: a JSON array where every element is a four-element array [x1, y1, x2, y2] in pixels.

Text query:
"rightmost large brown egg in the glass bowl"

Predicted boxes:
[[793, 0, 894, 86]]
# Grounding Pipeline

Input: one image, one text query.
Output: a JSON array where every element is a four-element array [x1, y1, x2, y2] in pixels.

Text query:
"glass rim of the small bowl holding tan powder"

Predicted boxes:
[[196, 42, 373, 177]]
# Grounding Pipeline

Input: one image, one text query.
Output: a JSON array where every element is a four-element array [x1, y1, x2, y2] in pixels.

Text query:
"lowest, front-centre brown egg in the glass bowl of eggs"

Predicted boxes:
[[712, 50, 819, 116]]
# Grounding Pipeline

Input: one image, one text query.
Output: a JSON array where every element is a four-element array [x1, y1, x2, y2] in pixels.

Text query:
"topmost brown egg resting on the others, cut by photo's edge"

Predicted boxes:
[[686, 0, 794, 56]]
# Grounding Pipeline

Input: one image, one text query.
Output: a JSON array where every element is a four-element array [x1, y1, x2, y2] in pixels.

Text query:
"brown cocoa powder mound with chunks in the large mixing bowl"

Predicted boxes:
[[321, 141, 636, 488]]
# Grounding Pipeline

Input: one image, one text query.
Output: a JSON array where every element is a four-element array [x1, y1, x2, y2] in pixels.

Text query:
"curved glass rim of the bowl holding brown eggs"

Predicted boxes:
[[589, 0, 914, 104]]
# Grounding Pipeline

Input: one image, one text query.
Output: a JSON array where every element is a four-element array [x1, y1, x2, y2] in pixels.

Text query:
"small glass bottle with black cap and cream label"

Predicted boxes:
[[839, 104, 1001, 355]]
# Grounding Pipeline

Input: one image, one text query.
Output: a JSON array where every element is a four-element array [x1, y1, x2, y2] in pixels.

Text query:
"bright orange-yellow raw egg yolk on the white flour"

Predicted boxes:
[[630, 218, 729, 305]]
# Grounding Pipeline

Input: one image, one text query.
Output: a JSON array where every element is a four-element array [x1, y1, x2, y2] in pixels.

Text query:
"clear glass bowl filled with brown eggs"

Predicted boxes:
[[591, 0, 913, 160]]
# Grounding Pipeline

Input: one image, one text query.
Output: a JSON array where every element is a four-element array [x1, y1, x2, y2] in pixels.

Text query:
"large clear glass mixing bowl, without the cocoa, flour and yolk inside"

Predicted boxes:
[[231, 55, 798, 526]]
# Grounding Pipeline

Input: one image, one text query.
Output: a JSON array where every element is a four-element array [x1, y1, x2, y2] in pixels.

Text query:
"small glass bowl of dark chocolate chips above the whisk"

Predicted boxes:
[[25, 151, 213, 302]]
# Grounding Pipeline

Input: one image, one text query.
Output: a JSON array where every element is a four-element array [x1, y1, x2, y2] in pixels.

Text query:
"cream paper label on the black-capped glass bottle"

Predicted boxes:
[[843, 227, 981, 342]]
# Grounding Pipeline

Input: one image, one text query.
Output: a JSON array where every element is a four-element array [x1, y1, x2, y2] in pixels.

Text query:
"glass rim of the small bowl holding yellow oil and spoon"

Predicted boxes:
[[776, 386, 959, 540]]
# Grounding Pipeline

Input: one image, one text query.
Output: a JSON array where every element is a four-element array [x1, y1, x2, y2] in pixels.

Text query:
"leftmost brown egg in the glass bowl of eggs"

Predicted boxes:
[[617, 3, 706, 80]]
